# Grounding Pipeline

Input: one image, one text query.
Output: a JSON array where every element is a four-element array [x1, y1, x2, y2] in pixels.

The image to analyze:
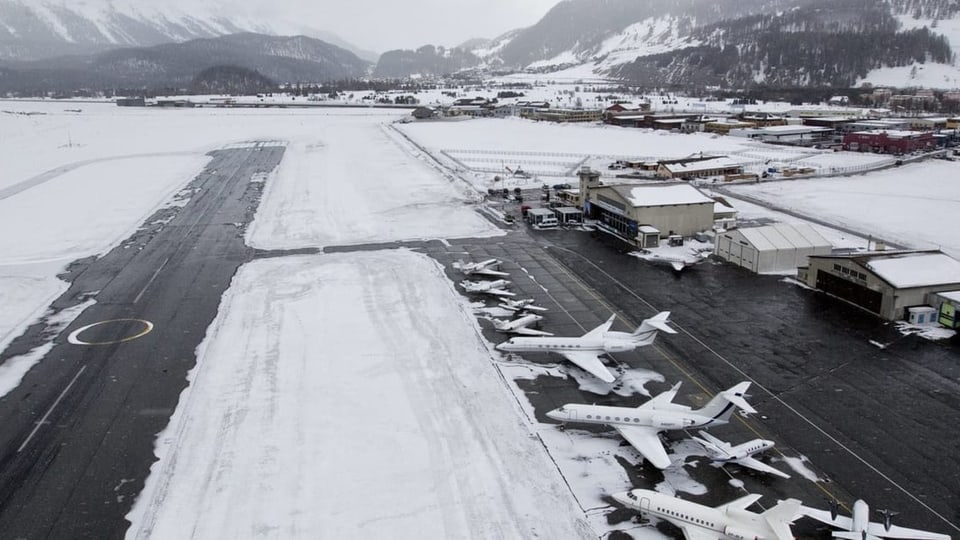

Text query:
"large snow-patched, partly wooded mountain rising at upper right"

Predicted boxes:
[[377, 0, 960, 88]]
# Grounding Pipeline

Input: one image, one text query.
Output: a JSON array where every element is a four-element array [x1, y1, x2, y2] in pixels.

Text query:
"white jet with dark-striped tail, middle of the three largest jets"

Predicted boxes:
[[547, 382, 757, 469]]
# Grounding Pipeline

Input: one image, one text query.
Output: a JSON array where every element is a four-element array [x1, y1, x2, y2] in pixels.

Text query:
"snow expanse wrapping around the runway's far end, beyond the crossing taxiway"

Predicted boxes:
[[0, 101, 501, 374]]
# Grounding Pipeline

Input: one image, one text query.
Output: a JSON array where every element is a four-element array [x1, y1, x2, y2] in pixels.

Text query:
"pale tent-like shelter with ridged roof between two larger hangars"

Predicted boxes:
[[715, 223, 833, 274]]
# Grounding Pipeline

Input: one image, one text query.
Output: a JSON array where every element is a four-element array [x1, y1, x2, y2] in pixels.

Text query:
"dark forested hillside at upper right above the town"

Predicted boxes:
[[611, 0, 956, 87]]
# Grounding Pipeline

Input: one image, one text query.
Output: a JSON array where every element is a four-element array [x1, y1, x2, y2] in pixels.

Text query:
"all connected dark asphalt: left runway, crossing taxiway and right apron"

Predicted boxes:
[[0, 154, 960, 539]]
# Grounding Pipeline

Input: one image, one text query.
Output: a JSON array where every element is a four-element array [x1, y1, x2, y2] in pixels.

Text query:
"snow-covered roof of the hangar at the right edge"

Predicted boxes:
[[860, 252, 960, 289]]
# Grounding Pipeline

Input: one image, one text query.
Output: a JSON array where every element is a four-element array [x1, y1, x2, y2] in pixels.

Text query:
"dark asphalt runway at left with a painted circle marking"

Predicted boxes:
[[0, 145, 284, 539]]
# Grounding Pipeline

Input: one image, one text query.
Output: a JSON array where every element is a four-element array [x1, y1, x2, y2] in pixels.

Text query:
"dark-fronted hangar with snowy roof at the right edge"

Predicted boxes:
[[799, 250, 960, 321]]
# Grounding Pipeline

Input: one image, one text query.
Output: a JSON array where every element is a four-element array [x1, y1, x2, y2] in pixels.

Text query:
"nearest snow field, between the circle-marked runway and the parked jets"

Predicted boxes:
[[128, 250, 596, 538]]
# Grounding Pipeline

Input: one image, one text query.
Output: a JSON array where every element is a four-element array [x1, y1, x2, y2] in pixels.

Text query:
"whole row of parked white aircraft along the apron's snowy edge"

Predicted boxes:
[[454, 259, 950, 540]]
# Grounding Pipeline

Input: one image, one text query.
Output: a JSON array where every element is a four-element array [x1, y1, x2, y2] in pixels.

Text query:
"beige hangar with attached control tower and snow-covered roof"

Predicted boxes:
[[577, 167, 717, 248]]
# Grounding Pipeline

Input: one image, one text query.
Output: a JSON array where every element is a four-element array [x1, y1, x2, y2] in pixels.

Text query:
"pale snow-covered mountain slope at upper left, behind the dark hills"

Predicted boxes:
[[0, 0, 376, 61]]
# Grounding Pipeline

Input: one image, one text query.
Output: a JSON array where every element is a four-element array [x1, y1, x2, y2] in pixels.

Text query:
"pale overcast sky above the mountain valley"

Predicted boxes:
[[218, 0, 560, 52]]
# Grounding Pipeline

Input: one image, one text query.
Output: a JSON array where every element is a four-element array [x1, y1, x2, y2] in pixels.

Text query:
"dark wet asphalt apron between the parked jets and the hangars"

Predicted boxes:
[[429, 220, 960, 537]]
